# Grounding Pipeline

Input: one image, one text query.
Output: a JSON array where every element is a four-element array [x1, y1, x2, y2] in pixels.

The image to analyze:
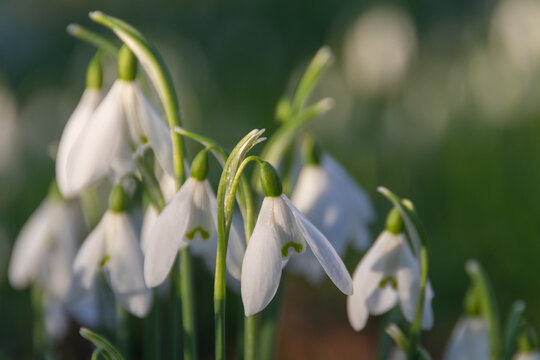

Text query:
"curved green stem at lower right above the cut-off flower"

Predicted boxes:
[[465, 260, 501, 360]]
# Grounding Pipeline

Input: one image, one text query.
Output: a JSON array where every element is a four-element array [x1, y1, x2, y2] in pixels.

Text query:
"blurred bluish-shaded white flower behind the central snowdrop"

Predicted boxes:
[[291, 155, 375, 283]]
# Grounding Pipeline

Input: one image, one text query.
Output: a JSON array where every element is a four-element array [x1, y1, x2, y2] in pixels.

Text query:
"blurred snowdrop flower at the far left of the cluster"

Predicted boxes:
[[8, 183, 88, 340]]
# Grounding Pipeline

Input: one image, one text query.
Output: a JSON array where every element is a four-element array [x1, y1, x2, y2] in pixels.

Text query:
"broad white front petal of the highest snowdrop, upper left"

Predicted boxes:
[[65, 81, 129, 195]]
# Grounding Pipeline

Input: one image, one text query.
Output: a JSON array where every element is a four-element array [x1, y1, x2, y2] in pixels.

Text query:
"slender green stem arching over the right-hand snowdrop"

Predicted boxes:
[[377, 187, 429, 360]]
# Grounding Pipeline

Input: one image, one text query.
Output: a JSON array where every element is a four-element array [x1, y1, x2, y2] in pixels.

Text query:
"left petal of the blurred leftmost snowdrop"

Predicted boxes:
[[8, 199, 61, 289]]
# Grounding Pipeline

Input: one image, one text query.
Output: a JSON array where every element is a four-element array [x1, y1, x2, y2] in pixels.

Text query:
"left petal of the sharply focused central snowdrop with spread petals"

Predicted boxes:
[[241, 198, 282, 316]]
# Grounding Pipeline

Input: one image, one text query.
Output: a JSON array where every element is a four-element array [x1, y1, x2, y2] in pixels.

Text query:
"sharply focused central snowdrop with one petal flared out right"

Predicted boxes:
[[241, 162, 353, 316]]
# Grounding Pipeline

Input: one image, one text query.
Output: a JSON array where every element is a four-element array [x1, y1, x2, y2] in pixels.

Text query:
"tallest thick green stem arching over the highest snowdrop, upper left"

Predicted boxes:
[[90, 11, 194, 359]]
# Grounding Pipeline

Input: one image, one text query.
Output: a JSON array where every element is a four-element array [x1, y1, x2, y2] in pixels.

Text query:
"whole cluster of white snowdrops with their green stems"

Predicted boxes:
[[9, 12, 540, 360]]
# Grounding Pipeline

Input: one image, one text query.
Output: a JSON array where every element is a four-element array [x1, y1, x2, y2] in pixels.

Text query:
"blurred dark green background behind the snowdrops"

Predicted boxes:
[[0, 0, 540, 359]]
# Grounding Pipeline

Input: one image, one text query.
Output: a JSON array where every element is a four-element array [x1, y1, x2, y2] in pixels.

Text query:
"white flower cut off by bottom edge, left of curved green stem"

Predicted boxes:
[[444, 316, 490, 360]]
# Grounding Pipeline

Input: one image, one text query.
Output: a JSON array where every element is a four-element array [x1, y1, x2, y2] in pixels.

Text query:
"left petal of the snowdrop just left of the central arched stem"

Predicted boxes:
[[144, 178, 196, 287]]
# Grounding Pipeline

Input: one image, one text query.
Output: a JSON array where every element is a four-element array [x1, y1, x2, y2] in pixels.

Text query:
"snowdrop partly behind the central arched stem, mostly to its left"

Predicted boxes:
[[144, 149, 243, 287]]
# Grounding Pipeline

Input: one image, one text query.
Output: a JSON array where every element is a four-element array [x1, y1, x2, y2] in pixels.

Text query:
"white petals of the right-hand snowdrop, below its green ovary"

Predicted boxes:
[[347, 230, 433, 331]]
